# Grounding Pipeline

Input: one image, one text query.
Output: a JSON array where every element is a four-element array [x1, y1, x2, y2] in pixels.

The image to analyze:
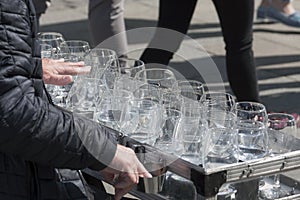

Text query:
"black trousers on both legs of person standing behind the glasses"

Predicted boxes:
[[141, 0, 259, 101]]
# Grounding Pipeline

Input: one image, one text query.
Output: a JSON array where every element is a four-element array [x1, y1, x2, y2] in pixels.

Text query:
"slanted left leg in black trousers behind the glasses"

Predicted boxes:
[[140, 0, 197, 65]]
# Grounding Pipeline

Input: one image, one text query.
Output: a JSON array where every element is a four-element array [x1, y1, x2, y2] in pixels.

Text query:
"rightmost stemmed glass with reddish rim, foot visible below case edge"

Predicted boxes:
[[259, 113, 297, 199]]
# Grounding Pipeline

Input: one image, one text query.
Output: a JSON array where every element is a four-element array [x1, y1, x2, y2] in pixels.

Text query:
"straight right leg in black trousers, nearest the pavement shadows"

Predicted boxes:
[[213, 0, 259, 101]]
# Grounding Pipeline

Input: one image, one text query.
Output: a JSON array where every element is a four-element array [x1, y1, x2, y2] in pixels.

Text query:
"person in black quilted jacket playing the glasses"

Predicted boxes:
[[0, 0, 151, 200]]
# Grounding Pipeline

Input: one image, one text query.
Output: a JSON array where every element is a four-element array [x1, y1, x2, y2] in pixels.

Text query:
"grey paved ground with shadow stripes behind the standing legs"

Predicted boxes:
[[40, 0, 300, 197]]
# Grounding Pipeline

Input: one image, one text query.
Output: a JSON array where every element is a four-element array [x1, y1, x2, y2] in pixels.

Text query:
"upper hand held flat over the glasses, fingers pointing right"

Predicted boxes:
[[42, 58, 91, 85]]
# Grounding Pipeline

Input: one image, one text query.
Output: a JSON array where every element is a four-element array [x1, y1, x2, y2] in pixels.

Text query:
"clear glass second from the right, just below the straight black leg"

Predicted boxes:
[[234, 102, 268, 161]]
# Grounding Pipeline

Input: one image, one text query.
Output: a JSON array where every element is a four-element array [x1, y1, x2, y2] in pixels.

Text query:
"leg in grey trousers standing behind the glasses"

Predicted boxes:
[[88, 0, 127, 55]]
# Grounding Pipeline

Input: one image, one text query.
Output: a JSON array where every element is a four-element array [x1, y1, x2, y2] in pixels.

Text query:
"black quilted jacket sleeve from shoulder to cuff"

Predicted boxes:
[[0, 0, 116, 170]]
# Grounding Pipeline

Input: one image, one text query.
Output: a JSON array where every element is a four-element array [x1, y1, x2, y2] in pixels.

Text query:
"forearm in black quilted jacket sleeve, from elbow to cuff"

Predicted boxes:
[[0, 88, 116, 169]]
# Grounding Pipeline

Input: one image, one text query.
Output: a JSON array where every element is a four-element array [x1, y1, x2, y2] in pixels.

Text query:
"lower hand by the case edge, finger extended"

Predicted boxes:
[[101, 145, 152, 200]]
